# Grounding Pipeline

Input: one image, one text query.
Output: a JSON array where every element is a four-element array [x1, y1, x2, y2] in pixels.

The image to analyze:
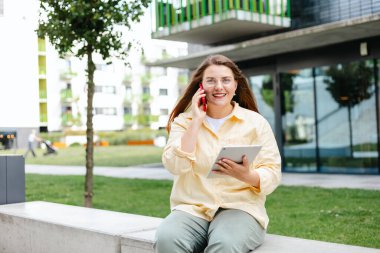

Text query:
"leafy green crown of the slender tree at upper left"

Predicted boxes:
[[37, 0, 150, 60]]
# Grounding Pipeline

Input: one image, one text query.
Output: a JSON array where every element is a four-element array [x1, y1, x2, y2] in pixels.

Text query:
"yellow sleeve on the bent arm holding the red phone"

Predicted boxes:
[[162, 117, 195, 175]]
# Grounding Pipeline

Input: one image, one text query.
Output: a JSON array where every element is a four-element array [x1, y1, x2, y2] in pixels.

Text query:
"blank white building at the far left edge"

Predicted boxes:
[[0, 0, 40, 147]]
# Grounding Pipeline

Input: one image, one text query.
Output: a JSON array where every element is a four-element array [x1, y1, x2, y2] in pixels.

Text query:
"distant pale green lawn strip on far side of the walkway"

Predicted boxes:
[[0, 145, 162, 167]]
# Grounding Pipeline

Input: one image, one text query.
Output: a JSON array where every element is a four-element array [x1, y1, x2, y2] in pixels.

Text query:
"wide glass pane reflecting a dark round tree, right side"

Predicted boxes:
[[316, 60, 378, 173]]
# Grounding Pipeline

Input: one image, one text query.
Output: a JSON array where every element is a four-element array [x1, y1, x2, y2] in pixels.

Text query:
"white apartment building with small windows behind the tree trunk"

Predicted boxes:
[[54, 10, 188, 131]]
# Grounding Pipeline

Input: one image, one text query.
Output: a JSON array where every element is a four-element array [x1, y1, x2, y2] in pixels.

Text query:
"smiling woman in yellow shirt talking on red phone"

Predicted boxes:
[[155, 55, 281, 253]]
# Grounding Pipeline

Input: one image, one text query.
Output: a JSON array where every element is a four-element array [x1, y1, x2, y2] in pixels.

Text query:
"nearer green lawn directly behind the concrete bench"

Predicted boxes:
[[26, 174, 380, 248]]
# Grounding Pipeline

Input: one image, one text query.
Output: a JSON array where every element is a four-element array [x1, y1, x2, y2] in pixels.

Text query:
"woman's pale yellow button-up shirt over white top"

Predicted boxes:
[[162, 103, 281, 229]]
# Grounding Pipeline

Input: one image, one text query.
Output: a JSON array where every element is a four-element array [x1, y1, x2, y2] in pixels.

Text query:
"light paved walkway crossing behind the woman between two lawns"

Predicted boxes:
[[25, 164, 380, 190]]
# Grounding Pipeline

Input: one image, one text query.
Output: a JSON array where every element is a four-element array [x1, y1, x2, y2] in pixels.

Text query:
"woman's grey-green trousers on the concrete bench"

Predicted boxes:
[[154, 209, 266, 253]]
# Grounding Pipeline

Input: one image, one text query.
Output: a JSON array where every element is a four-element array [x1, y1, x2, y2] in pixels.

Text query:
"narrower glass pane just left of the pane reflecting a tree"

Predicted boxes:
[[280, 69, 317, 171]]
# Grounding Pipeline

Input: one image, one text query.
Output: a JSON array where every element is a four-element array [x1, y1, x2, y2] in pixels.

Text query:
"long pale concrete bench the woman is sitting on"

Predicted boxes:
[[0, 201, 380, 253]]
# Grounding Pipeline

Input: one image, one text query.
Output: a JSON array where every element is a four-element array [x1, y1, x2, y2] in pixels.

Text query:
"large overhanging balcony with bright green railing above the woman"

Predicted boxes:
[[152, 0, 291, 45]]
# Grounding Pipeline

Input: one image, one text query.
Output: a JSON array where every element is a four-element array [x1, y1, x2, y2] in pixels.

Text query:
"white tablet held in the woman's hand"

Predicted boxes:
[[208, 145, 261, 177]]
